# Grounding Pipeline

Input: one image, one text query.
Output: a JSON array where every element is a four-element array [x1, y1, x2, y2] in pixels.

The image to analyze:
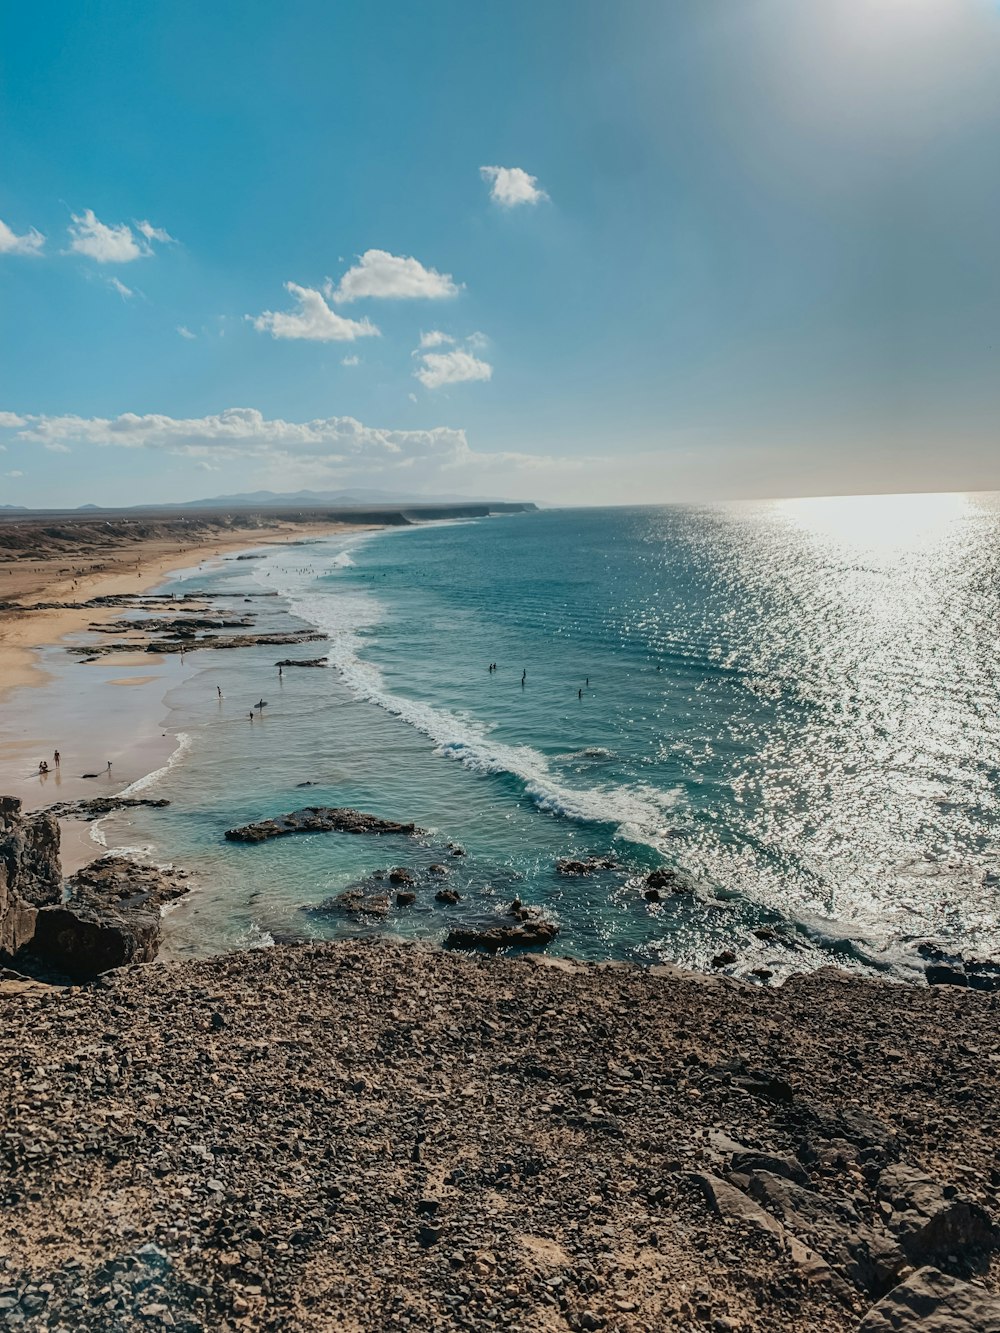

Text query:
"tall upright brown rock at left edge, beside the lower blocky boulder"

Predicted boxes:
[[0, 796, 63, 958]]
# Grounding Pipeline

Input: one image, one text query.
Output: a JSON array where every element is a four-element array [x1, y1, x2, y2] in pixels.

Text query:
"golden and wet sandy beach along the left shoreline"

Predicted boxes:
[[0, 511, 372, 815]]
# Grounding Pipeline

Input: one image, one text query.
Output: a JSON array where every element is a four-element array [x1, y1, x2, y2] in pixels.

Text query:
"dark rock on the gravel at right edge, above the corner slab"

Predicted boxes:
[[879, 1162, 1000, 1264]]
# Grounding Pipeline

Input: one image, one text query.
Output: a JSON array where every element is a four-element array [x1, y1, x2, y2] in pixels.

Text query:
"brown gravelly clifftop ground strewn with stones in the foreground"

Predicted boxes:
[[0, 941, 1000, 1333]]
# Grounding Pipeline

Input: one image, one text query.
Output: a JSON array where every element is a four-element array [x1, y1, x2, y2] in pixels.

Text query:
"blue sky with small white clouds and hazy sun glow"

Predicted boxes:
[[0, 0, 1000, 507]]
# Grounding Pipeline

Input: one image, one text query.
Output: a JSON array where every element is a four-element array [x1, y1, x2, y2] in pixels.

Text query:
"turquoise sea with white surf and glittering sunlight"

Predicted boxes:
[[108, 496, 1000, 976]]
